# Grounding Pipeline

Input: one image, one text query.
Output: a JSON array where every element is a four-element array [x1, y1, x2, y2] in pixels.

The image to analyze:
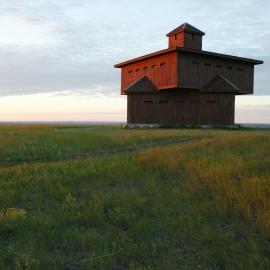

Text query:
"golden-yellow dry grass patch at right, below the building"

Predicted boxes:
[[140, 133, 270, 231]]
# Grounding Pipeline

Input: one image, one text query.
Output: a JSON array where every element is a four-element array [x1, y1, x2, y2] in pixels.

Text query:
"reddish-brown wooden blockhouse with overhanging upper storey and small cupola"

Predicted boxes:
[[115, 23, 263, 125]]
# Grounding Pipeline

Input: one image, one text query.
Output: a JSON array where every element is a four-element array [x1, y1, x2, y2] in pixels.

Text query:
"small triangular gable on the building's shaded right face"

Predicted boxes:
[[200, 74, 239, 93]]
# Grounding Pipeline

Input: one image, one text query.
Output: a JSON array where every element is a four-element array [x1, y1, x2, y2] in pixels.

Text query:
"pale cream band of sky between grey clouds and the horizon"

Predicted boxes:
[[0, 92, 270, 124]]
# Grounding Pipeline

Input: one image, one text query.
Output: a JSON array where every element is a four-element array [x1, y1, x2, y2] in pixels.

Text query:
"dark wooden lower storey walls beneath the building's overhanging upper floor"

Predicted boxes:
[[127, 90, 235, 125]]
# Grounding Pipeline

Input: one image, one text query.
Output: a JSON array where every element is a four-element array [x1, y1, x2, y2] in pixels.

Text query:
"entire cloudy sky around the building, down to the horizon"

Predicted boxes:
[[0, 0, 270, 123]]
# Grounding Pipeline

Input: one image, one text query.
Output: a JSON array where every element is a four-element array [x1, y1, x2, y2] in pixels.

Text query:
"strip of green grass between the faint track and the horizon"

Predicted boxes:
[[0, 126, 230, 165]]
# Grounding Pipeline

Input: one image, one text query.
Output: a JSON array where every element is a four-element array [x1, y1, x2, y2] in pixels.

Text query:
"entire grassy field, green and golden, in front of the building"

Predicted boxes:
[[0, 126, 270, 270]]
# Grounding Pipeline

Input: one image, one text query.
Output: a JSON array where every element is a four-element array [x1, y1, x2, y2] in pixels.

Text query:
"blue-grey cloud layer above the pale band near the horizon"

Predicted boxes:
[[0, 0, 270, 96]]
